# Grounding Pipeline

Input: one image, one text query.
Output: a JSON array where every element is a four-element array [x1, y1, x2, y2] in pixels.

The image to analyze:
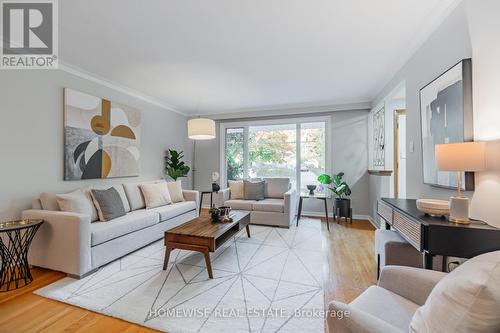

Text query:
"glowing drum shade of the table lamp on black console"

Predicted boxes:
[[435, 142, 486, 171]]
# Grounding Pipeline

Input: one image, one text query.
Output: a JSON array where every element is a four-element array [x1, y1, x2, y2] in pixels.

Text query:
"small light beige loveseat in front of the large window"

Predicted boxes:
[[217, 178, 297, 228]]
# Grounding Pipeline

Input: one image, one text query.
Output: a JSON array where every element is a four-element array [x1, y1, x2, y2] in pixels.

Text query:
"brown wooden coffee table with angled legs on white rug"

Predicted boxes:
[[163, 211, 250, 279]]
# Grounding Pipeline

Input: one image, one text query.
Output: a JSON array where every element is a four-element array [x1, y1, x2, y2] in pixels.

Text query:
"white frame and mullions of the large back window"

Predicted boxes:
[[219, 116, 333, 193]]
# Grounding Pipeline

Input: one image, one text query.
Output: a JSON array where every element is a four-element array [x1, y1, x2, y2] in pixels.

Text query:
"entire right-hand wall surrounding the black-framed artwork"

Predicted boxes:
[[370, 0, 500, 226]]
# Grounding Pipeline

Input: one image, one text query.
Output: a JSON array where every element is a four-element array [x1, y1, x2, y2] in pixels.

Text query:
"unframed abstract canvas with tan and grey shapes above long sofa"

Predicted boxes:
[[64, 88, 142, 180]]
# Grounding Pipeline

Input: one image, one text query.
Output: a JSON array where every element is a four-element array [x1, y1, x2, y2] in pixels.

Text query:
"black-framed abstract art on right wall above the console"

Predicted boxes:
[[420, 59, 474, 190]]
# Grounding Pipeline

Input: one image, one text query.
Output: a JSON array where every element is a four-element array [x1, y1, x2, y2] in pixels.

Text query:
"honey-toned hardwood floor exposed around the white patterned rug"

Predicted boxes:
[[0, 214, 376, 333]]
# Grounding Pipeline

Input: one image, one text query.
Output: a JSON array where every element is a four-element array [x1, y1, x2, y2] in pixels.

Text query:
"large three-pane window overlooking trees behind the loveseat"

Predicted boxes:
[[220, 117, 329, 191]]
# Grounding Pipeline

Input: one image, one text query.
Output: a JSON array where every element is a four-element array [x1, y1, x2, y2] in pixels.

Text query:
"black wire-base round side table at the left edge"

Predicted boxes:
[[0, 220, 43, 291]]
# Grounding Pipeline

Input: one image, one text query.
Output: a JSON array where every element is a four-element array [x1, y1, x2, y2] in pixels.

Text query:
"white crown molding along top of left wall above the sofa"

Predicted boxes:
[[58, 61, 188, 117]]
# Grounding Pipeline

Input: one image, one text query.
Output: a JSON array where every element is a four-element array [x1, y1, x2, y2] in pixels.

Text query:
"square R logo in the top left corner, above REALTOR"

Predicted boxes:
[[2, 1, 53, 55]]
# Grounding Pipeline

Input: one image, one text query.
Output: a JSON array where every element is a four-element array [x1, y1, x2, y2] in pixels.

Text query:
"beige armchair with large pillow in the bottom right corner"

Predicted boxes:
[[327, 251, 500, 333]]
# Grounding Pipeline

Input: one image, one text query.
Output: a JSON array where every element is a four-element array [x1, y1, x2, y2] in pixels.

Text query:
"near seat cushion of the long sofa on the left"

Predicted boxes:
[[90, 209, 160, 246]]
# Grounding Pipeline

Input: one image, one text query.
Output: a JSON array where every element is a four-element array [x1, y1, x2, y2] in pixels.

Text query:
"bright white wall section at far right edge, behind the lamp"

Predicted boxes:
[[465, 0, 500, 227]]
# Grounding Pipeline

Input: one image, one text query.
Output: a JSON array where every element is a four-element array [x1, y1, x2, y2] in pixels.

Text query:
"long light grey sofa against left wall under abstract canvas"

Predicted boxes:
[[22, 183, 199, 278]]
